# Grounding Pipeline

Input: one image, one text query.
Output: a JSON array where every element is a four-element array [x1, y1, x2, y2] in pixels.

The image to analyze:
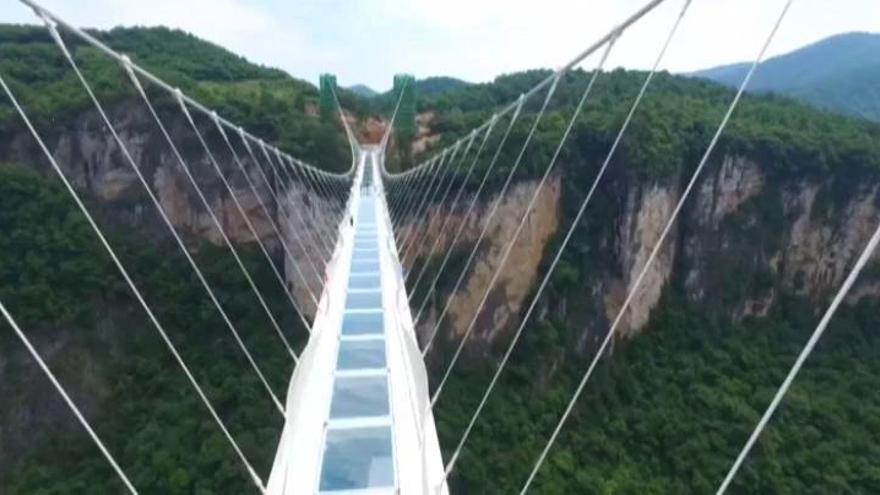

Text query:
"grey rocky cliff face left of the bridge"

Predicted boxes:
[[0, 102, 334, 314]]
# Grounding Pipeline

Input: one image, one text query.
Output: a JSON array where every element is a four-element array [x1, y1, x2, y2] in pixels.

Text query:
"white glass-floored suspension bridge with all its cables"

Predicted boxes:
[[0, 0, 880, 495]]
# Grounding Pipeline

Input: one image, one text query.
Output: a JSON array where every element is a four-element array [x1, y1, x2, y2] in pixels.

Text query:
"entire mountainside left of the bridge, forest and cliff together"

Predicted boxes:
[[0, 26, 351, 494]]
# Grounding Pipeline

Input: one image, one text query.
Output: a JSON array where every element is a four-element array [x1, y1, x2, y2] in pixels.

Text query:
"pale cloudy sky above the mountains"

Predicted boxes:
[[0, 0, 880, 90]]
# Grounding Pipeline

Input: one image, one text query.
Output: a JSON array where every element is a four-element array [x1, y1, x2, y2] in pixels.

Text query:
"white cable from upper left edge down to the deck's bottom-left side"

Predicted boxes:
[[0, 69, 266, 492]]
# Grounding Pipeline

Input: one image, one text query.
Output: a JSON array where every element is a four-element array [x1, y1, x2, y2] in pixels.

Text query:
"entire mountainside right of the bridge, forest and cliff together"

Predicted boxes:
[[400, 71, 880, 494]]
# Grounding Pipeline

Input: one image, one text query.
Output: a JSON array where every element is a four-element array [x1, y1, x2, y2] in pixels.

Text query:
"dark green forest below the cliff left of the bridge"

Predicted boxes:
[[0, 165, 305, 494]]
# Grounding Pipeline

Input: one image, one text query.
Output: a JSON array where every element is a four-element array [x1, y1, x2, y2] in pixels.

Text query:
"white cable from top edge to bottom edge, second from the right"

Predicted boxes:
[[520, 0, 793, 495]]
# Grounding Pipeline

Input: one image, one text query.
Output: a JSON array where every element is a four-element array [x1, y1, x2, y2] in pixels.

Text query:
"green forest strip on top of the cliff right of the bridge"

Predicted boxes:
[[416, 70, 880, 181]]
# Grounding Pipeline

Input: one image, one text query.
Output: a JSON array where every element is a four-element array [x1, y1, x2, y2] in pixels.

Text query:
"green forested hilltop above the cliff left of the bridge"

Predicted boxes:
[[0, 25, 351, 171]]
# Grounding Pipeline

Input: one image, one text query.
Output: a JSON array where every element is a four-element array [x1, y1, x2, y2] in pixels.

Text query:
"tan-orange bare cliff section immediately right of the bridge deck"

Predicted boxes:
[[404, 178, 560, 344]]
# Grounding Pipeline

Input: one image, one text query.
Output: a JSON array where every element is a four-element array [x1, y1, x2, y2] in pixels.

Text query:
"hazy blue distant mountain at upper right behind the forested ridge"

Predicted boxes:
[[691, 33, 880, 121]]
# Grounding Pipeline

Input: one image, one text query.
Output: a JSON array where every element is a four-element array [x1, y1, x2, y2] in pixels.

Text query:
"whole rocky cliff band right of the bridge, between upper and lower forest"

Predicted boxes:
[[405, 155, 880, 362]]
